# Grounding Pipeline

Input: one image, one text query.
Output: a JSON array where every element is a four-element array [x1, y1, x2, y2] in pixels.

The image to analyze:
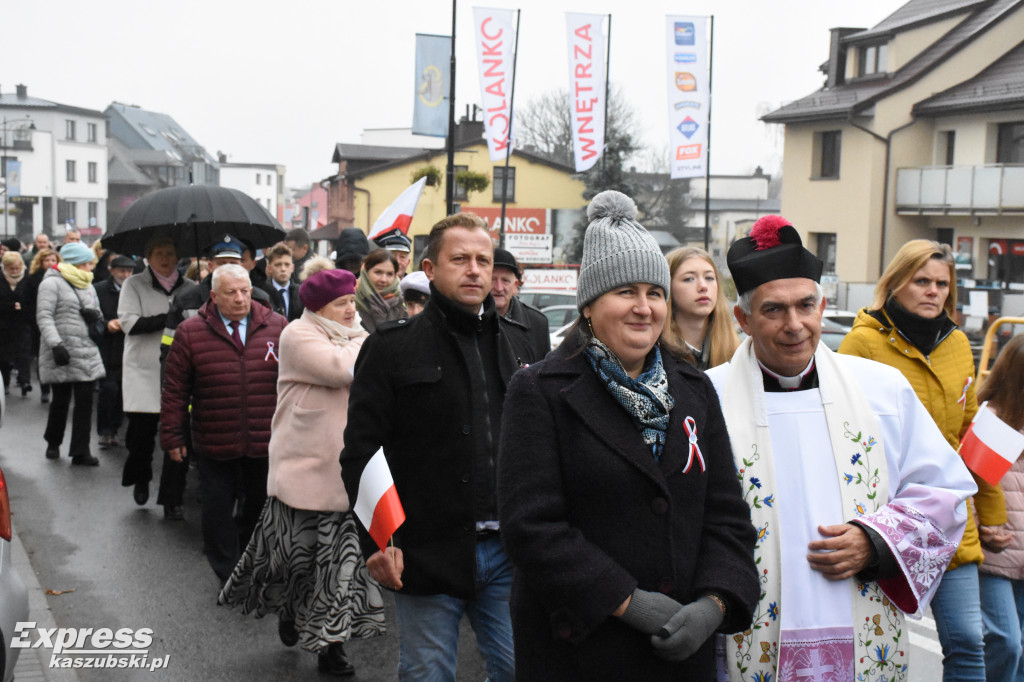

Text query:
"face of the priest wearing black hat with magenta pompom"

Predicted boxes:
[[734, 278, 825, 377]]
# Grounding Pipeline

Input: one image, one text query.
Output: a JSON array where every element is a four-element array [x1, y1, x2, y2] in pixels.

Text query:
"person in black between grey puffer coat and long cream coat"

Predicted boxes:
[[95, 256, 135, 447]]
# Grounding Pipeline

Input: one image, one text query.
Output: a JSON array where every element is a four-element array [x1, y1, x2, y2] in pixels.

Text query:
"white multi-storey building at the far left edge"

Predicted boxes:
[[0, 85, 108, 242]]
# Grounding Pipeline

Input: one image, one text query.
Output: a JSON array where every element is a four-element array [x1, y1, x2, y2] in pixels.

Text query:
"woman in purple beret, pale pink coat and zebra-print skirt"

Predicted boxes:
[[219, 269, 384, 676]]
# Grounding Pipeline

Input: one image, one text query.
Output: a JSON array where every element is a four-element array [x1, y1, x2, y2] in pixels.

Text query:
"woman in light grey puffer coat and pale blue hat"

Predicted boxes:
[[36, 242, 106, 466]]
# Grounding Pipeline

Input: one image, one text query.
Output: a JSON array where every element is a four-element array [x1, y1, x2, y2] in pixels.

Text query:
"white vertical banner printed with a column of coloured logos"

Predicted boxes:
[[666, 15, 711, 179]]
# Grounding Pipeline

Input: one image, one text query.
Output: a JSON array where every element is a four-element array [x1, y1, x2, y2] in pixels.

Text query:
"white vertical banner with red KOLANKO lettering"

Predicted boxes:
[[473, 7, 515, 161]]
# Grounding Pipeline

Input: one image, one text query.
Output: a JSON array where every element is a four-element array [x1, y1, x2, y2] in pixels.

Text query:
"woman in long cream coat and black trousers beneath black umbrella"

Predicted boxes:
[[118, 237, 196, 512]]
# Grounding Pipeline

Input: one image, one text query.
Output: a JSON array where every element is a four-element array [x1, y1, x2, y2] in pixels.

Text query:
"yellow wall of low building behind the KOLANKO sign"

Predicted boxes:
[[355, 142, 587, 251]]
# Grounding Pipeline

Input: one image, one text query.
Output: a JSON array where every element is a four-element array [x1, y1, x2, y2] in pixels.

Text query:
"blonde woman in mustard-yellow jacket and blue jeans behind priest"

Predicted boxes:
[[839, 240, 1013, 682]]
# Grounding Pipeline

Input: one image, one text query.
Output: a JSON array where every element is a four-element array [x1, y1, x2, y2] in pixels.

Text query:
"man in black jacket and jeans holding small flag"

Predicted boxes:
[[341, 213, 540, 680]]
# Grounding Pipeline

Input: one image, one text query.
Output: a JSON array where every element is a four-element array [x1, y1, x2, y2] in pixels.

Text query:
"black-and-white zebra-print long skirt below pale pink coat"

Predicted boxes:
[[217, 498, 385, 652]]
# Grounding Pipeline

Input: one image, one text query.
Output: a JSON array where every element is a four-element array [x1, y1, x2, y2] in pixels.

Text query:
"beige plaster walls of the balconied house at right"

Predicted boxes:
[[782, 2, 1024, 283]]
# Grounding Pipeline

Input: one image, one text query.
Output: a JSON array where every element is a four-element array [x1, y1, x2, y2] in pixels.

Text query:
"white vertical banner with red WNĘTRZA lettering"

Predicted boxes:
[[565, 12, 608, 173]]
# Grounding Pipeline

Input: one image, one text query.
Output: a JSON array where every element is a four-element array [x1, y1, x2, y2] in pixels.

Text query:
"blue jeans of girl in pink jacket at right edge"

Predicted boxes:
[[979, 573, 1024, 682]]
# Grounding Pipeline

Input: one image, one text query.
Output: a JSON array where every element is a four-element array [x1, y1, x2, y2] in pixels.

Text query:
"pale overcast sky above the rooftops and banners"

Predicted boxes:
[[12, 0, 903, 186]]
